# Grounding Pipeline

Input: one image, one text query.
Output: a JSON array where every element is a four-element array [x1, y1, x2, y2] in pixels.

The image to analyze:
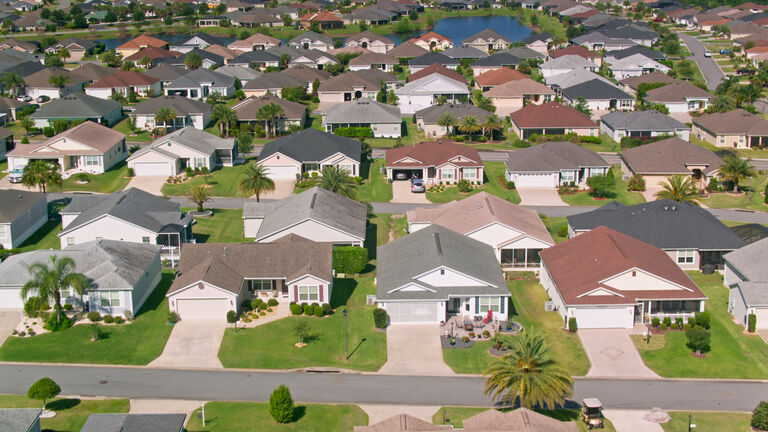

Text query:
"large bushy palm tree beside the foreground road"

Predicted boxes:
[[483, 332, 573, 409]]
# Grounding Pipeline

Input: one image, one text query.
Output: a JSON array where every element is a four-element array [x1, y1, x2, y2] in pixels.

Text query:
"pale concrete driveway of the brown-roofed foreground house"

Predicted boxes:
[[149, 320, 227, 369]]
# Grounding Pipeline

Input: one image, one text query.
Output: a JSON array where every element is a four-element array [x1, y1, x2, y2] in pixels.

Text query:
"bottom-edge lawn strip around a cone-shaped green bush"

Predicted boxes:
[[186, 402, 368, 432]]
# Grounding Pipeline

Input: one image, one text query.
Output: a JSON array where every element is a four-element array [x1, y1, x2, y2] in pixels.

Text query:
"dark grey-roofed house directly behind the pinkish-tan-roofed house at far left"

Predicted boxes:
[[29, 93, 123, 128]]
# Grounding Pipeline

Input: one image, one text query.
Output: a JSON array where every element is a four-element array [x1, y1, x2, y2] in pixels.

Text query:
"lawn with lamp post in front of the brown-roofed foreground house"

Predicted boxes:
[[219, 277, 387, 371]]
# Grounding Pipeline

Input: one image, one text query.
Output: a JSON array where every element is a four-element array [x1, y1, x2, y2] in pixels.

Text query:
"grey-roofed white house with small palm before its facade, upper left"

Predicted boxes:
[[129, 96, 211, 131]]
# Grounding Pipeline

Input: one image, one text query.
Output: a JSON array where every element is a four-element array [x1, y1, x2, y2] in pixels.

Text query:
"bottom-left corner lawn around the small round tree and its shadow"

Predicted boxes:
[[0, 395, 129, 432]]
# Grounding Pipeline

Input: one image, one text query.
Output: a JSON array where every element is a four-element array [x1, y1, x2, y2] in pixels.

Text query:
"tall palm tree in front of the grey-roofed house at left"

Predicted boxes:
[[21, 255, 91, 330]]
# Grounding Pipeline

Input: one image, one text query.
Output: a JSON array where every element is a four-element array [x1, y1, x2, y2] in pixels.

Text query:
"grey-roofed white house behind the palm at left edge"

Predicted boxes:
[[0, 240, 162, 314]]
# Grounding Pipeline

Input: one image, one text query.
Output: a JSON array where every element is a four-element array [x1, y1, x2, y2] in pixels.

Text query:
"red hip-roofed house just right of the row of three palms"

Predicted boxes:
[[509, 102, 599, 139]]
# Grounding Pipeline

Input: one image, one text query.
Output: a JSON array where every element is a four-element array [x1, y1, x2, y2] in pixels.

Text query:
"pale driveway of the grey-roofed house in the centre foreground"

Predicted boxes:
[[379, 324, 453, 375]]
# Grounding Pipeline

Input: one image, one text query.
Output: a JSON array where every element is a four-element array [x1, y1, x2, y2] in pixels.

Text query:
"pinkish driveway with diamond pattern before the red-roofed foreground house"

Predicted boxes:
[[578, 329, 659, 378]]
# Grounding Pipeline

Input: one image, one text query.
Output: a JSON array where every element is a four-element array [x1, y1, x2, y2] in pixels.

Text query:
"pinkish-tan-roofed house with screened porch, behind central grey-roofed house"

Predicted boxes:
[[406, 192, 555, 270]]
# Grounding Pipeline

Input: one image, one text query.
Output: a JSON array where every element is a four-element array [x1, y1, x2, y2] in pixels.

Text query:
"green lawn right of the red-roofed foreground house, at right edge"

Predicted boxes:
[[635, 272, 768, 379]]
